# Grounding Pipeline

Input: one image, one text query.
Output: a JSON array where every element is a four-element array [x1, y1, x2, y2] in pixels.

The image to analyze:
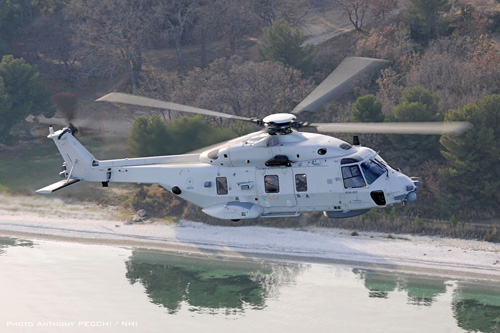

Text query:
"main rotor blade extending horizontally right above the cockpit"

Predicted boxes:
[[309, 122, 472, 135]]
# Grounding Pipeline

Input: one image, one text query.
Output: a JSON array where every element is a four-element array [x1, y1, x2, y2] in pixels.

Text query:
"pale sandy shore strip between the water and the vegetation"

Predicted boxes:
[[0, 194, 500, 281]]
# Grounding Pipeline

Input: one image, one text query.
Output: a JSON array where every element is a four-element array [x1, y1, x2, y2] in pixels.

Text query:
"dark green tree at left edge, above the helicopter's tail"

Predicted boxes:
[[0, 55, 55, 143]]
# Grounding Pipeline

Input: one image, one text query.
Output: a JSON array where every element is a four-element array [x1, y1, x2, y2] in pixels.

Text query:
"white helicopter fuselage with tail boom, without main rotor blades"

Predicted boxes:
[[38, 129, 419, 220]]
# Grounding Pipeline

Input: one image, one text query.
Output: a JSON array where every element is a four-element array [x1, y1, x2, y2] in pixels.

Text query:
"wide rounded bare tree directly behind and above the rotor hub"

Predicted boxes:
[[172, 56, 313, 118]]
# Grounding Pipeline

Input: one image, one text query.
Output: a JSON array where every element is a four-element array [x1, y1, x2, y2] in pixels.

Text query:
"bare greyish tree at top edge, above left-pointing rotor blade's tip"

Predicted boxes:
[[67, 0, 152, 93]]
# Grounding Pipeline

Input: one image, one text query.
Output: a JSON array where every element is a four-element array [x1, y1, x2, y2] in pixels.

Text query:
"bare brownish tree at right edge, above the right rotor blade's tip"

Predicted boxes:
[[405, 36, 500, 111]]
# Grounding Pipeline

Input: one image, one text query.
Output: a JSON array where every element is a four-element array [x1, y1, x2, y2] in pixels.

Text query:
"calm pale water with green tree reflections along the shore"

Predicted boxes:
[[0, 238, 500, 332]]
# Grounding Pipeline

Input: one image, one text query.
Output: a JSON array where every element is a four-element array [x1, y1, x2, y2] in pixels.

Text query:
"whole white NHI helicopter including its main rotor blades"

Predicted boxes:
[[37, 57, 470, 221]]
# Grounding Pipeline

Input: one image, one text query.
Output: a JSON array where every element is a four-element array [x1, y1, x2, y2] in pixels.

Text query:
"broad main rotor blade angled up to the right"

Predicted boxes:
[[292, 57, 389, 114]]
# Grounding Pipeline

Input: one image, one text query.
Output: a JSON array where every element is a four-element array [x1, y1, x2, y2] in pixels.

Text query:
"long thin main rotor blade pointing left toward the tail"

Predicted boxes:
[[96, 93, 258, 123]]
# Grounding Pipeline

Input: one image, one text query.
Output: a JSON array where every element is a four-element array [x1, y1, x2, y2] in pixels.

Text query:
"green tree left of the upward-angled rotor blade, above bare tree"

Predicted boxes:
[[259, 19, 314, 74]]
